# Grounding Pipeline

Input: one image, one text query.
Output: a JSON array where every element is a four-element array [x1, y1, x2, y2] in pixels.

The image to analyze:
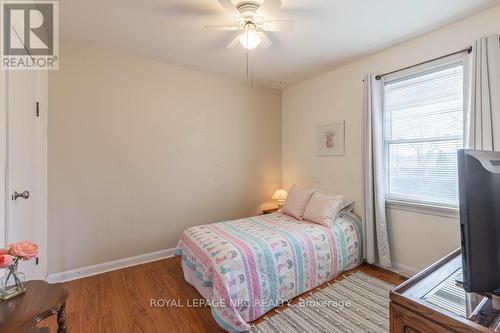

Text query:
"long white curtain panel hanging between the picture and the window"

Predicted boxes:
[[364, 75, 392, 267]]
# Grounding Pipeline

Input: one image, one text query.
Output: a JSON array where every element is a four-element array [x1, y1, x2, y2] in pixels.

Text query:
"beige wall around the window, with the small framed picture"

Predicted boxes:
[[282, 7, 500, 273]]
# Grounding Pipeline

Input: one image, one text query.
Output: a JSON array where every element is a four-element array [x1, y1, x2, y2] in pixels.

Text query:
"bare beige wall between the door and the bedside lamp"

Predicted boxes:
[[48, 43, 281, 273]]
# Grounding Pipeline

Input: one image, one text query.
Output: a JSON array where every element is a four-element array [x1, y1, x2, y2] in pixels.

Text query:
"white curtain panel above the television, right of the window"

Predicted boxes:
[[465, 35, 500, 151]]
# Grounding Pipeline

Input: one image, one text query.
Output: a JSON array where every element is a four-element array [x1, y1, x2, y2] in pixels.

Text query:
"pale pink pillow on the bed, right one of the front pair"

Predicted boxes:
[[304, 192, 345, 227]]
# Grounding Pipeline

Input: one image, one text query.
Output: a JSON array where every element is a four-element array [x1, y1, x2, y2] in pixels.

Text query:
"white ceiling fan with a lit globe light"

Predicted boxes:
[[205, 0, 294, 50]]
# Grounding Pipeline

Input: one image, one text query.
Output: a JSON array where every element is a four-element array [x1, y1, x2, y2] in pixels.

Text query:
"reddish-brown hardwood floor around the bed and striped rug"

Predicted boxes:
[[38, 257, 404, 333]]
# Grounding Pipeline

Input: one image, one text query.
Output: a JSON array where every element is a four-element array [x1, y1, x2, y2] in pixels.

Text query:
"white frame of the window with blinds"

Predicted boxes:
[[381, 54, 468, 213]]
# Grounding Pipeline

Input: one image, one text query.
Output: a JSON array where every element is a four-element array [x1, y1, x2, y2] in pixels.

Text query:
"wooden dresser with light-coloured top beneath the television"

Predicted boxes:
[[390, 250, 500, 333]]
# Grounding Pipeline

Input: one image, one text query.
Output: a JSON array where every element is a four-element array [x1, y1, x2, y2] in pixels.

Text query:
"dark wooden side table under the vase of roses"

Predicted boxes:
[[0, 280, 68, 333]]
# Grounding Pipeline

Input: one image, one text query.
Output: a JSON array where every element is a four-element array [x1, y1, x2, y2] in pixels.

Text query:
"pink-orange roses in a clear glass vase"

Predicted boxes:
[[0, 241, 38, 300]]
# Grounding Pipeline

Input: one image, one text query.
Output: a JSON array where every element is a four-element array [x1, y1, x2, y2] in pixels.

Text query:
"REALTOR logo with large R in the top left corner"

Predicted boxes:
[[1, 1, 59, 70]]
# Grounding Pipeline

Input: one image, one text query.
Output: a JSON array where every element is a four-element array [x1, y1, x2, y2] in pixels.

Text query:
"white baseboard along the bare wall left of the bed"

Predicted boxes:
[[46, 249, 175, 283]]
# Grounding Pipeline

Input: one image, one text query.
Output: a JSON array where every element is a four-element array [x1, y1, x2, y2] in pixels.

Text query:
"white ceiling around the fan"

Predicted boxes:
[[59, 0, 500, 85]]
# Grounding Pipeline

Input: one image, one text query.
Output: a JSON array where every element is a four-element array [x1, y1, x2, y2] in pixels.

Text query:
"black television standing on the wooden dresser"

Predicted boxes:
[[458, 149, 500, 295]]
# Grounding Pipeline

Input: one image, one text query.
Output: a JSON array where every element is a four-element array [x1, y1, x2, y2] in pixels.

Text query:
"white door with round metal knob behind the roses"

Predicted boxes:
[[5, 70, 47, 280]]
